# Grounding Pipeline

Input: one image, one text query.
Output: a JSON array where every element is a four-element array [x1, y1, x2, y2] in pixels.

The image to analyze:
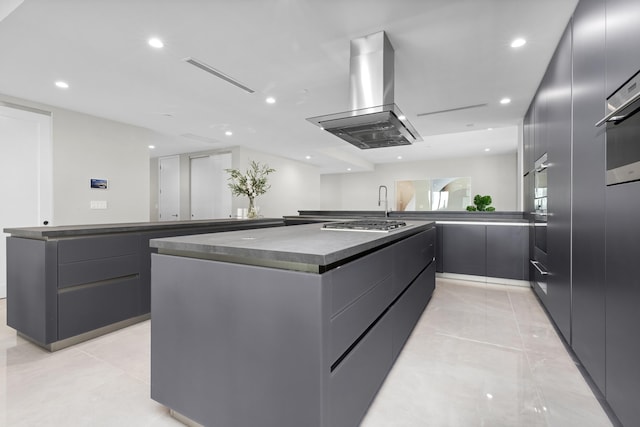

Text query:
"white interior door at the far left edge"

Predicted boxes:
[[0, 103, 53, 298]]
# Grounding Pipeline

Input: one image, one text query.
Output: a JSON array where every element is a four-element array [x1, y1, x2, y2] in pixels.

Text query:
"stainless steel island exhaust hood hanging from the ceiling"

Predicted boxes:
[[307, 31, 422, 149]]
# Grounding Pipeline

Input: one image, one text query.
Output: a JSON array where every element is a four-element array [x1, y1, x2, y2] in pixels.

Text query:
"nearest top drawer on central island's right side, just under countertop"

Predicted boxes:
[[331, 247, 392, 316]]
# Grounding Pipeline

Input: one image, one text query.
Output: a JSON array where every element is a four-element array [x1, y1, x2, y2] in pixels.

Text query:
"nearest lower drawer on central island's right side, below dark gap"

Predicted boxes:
[[326, 310, 392, 427]]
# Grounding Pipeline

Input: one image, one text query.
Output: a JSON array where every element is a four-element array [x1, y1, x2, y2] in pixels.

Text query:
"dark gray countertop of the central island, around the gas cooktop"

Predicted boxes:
[[150, 221, 435, 271]]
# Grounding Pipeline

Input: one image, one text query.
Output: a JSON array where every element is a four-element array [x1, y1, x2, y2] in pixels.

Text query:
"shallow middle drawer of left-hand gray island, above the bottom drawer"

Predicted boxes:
[[58, 254, 140, 288]]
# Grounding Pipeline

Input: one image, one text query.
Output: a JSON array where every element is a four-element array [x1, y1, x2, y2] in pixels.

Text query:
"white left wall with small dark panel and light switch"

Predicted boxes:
[[0, 95, 154, 225]]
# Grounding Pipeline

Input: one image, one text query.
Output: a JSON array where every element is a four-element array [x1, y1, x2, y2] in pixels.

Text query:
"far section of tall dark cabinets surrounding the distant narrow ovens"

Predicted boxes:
[[523, 23, 572, 342]]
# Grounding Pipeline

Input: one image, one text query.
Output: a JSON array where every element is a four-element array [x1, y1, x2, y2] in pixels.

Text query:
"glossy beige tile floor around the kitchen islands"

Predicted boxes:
[[0, 278, 611, 427]]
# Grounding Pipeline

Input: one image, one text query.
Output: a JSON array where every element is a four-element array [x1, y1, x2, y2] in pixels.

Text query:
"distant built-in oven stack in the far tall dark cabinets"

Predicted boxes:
[[530, 153, 549, 294]]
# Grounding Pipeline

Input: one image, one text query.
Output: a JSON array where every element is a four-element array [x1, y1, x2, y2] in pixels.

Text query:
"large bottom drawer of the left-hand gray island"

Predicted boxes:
[[58, 276, 140, 340]]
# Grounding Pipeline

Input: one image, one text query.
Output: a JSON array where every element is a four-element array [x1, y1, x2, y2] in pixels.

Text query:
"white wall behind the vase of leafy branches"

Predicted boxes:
[[149, 147, 320, 220]]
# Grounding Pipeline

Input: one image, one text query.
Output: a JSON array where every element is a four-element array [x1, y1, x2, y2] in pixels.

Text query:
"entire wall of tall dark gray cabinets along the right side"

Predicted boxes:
[[523, 0, 640, 427]]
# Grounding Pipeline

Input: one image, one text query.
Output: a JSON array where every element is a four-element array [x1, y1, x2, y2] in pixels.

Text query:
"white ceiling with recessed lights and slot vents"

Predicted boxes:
[[0, 0, 577, 173]]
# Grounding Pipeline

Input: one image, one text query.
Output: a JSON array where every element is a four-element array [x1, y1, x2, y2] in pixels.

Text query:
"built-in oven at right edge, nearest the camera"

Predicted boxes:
[[596, 71, 640, 185]]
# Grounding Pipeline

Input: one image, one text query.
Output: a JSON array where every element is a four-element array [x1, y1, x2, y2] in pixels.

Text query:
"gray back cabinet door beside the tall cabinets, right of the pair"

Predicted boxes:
[[487, 225, 529, 280]]
